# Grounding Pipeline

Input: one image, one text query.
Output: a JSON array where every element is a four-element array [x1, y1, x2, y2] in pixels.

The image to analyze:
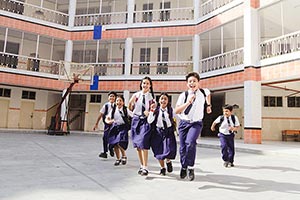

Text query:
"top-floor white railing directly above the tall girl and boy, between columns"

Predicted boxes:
[[133, 7, 194, 23]]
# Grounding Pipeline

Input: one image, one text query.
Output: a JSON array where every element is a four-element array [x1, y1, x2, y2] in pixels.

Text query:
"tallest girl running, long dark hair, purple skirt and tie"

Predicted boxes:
[[129, 76, 155, 176]]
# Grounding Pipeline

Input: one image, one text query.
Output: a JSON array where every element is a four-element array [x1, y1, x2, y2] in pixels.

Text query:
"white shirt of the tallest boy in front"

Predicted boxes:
[[176, 88, 210, 122]]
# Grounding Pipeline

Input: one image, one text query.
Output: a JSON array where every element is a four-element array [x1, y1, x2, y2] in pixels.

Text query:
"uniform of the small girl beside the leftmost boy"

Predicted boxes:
[[108, 108, 132, 150]]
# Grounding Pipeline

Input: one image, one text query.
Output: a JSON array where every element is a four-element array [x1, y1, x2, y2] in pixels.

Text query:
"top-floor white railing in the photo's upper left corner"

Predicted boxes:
[[0, 0, 69, 26]]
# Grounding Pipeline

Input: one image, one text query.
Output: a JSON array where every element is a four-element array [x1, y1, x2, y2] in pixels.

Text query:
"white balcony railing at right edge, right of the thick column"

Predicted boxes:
[[260, 31, 300, 59]]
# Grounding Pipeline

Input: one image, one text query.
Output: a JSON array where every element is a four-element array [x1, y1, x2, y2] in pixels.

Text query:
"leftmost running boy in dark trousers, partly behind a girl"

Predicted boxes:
[[93, 92, 117, 158]]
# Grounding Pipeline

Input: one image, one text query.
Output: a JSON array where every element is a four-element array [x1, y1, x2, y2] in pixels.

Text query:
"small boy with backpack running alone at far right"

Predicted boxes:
[[211, 104, 240, 167]]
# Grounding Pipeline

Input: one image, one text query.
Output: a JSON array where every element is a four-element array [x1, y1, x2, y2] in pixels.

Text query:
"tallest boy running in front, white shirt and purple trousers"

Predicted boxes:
[[175, 72, 211, 181]]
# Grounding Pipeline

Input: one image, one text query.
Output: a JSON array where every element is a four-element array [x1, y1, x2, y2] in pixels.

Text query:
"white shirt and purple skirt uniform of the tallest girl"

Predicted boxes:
[[131, 91, 154, 149]]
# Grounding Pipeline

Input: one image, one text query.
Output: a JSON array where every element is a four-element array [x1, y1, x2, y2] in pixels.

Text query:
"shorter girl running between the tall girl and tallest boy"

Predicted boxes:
[[148, 93, 177, 176]]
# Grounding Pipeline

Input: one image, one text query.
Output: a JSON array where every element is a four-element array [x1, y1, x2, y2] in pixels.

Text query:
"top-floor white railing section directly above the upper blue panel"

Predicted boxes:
[[74, 12, 127, 26]]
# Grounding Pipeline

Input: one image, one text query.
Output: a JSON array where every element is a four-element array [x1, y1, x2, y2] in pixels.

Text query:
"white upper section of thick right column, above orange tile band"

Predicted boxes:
[[244, 1, 260, 67]]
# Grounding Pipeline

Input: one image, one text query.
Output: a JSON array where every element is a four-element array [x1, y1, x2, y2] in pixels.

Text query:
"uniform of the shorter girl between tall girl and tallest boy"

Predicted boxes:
[[147, 107, 177, 160]]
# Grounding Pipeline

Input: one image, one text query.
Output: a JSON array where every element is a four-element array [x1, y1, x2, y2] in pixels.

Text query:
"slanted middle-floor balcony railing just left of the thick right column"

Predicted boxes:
[[200, 48, 244, 73]]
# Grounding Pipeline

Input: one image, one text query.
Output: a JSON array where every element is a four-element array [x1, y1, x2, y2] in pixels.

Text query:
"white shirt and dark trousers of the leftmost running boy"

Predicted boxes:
[[100, 102, 116, 153]]
